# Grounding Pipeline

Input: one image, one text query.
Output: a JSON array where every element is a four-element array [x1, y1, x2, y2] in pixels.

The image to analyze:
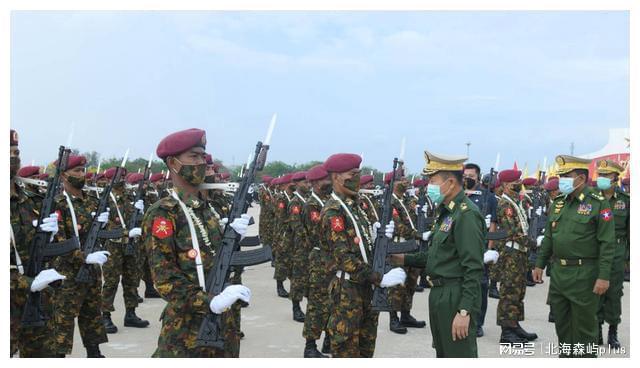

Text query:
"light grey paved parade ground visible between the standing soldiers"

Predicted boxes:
[[71, 205, 630, 358]]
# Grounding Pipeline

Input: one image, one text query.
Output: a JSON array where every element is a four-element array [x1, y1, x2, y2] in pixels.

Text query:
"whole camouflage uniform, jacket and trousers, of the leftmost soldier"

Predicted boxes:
[[9, 183, 56, 358]]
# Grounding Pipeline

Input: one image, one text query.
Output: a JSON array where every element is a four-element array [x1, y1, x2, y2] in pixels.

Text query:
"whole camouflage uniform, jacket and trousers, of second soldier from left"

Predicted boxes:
[[54, 192, 108, 354]]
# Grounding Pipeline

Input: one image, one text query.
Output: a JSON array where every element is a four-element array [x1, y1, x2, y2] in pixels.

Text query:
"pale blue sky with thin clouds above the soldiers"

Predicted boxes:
[[11, 11, 629, 172]]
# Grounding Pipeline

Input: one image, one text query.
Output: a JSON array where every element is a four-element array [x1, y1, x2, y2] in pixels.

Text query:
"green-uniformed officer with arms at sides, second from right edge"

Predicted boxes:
[[534, 155, 615, 356]]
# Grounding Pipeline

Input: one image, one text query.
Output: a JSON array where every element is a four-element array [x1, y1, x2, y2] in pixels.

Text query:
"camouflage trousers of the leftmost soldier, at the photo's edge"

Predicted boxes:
[[9, 270, 57, 358]]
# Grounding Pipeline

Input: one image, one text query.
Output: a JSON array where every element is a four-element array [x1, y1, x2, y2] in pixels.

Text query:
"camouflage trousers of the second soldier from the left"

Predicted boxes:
[[54, 266, 109, 354]]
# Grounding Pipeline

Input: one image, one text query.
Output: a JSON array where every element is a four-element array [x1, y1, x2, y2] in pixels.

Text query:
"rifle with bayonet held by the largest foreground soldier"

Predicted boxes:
[[196, 115, 276, 349]]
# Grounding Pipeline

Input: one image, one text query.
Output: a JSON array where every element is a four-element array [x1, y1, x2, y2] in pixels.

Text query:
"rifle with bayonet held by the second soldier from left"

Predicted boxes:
[[76, 150, 129, 283]]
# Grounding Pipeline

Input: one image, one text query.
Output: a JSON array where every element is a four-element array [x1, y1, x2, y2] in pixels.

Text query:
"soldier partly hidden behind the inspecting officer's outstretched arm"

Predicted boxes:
[[384, 169, 427, 334]]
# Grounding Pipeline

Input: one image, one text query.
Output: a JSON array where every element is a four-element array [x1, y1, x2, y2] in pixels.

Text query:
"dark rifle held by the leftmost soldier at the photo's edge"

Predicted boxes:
[[22, 146, 80, 327]]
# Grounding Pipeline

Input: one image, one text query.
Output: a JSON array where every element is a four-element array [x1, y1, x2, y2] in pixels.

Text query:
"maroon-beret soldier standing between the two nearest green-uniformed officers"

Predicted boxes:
[[496, 170, 538, 344]]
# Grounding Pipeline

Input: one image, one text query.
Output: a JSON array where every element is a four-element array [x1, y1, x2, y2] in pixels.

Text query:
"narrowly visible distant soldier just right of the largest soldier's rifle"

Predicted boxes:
[[273, 174, 293, 298]]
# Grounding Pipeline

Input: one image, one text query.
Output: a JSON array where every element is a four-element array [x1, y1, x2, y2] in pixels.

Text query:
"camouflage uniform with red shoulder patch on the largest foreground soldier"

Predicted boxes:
[[142, 192, 240, 357]]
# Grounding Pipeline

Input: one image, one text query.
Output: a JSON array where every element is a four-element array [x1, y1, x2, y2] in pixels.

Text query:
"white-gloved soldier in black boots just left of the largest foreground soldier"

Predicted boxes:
[[102, 167, 149, 333]]
